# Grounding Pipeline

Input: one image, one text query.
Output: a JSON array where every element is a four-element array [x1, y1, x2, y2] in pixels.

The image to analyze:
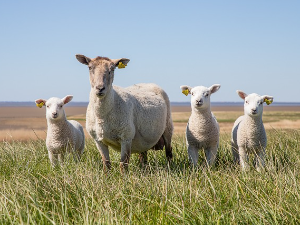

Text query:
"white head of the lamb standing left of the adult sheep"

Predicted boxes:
[[35, 95, 73, 120]]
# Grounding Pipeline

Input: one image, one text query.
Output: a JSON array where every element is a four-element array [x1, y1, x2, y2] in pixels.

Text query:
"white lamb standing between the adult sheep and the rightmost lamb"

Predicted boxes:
[[180, 84, 221, 167]]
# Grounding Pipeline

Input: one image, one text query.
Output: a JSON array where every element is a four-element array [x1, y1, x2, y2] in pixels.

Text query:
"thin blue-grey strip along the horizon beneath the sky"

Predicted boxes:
[[0, 102, 300, 107]]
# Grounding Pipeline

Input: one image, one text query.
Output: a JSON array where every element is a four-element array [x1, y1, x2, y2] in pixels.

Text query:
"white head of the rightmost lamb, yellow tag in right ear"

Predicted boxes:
[[236, 90, 273, 117]]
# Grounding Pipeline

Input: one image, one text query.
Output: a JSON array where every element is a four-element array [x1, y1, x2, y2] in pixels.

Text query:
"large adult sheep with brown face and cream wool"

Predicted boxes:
[[76, 54, 173, 172]]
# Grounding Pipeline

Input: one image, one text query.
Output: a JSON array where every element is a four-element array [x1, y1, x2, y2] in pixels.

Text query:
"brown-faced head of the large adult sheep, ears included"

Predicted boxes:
[[76, 55, 130, 98]]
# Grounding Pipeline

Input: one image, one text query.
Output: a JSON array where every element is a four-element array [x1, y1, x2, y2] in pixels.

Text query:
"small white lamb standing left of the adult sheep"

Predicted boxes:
[[35, 95, 85, 167]]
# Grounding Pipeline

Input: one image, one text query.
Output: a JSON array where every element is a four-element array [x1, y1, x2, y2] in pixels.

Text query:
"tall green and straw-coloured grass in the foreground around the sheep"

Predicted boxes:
[[0, 130, 300, 224]]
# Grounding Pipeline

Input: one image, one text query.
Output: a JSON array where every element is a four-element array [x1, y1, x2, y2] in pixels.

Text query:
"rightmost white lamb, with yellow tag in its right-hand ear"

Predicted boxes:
[[231, 90, 273, 171]]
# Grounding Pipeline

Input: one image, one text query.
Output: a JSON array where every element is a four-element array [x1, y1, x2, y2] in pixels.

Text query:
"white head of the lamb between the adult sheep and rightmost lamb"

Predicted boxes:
[[180, 84, 221, 110]]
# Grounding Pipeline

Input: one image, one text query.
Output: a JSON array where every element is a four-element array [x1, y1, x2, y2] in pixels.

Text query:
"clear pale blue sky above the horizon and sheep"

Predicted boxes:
[[0, 0, 300, 102]]
